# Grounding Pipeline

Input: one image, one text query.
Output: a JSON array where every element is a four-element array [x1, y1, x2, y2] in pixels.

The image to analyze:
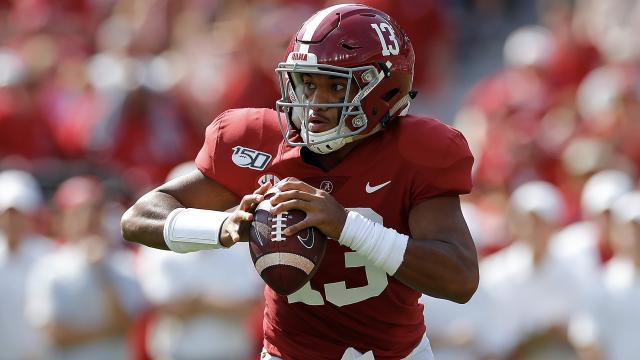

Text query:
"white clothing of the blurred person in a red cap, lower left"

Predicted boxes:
[[26, 244, 145, 360]]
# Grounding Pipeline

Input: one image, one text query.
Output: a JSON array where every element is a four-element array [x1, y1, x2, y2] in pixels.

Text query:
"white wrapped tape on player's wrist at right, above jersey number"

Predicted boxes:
[[338, 211, 409, 275]]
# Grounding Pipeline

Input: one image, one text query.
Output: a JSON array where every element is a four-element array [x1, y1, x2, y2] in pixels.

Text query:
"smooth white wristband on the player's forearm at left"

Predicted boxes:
[[162, 208, 231, 253]]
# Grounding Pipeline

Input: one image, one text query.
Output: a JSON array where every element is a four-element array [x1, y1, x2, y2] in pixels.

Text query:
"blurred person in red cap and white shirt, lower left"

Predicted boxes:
[[26, 177, 144, 360]]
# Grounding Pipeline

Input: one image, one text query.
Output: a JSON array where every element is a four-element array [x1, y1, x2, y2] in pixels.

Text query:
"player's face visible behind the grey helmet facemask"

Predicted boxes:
[[302, 74, 357, 133]]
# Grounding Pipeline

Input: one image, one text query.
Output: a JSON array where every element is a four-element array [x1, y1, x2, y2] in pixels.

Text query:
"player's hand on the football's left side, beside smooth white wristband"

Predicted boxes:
[[220, 182, 271, 247]]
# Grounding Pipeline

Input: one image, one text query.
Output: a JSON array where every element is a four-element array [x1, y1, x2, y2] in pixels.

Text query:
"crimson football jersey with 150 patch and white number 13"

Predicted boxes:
[[196, 109, 473, 360]]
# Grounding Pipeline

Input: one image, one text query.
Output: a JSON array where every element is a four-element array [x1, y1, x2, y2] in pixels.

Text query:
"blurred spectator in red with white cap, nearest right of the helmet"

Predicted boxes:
[[460, 26, 555, 186]]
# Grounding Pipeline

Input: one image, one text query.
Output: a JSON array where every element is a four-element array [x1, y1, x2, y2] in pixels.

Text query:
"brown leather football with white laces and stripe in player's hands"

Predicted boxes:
[[249, 192, 327, 296]]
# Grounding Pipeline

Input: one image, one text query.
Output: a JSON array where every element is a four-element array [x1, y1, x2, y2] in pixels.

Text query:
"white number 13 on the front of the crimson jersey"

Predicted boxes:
[[287, 208, 389, 306]]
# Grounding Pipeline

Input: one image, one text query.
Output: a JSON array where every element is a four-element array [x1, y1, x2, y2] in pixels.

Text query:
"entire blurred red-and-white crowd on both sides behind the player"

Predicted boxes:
[[0, 0, 640, 360]]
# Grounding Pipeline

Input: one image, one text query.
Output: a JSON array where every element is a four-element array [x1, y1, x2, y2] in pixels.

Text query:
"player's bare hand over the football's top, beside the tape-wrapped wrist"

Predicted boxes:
[[271, 178, 347, 239]]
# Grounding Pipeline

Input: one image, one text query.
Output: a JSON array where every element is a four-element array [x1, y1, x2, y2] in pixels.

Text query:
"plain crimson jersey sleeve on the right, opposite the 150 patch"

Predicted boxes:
[[404, 116, 473, 204]]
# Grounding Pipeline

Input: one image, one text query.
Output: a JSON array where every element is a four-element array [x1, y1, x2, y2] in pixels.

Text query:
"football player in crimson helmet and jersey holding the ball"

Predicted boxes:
[[122, 4, 478, 359]]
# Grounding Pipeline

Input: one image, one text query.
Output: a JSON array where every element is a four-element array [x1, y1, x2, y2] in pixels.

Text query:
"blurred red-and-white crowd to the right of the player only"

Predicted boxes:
[[423, 0, 640, 359]]
